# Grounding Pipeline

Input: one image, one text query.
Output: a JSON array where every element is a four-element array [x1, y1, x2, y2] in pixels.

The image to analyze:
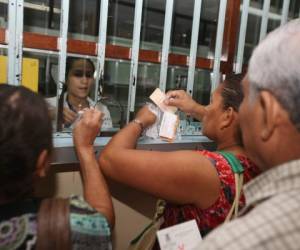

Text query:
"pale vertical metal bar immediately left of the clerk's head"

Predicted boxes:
[[56, 0, 70, 130]]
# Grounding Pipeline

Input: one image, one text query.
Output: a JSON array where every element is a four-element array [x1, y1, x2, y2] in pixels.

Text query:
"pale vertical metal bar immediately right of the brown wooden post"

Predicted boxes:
[[235, 0, 250, 74]]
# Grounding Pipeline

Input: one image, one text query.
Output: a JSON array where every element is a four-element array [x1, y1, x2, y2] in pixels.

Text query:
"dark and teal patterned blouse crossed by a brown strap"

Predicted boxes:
[[0, 196, 112, 250]]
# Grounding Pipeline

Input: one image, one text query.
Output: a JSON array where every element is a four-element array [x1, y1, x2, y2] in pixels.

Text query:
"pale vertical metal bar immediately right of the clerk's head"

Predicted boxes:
[[95, 0, 108, 102]]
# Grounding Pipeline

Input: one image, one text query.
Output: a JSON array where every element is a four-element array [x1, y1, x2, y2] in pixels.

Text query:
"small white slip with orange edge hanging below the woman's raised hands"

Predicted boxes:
[[159, 112, 179, 141]]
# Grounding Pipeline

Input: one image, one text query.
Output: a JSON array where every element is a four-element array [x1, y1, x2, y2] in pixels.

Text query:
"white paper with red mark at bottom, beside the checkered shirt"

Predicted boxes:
[[157, 220, 202, 250]]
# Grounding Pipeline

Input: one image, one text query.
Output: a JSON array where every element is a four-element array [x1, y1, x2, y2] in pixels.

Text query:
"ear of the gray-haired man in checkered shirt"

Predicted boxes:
[[259, 91, 281, 141]]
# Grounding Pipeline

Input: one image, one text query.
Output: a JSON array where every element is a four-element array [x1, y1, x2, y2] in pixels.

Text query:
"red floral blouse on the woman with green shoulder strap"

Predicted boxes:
[[161, 150, 259, 237]]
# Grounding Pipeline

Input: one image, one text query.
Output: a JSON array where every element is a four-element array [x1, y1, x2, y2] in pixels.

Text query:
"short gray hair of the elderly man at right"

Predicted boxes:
[[248, 19, 300, 130]]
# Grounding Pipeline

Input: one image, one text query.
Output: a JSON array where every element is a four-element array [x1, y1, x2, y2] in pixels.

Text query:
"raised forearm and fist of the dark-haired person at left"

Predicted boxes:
[[73, 109, 115, 227]]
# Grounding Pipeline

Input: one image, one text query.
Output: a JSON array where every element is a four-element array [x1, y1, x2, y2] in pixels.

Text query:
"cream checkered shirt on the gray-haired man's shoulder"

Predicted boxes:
[[199, 190, 300, 250]]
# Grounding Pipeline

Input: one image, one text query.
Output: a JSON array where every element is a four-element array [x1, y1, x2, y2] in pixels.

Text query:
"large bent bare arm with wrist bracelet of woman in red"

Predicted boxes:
[[99, 107, 220, 208]]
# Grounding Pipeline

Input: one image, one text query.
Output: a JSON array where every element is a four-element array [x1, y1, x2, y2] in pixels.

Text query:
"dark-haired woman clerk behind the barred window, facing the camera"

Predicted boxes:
[[57, 57, 112, 131]]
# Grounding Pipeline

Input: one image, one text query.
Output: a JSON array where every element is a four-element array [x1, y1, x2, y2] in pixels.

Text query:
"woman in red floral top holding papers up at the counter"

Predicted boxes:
[[99, 75, 258, 246]]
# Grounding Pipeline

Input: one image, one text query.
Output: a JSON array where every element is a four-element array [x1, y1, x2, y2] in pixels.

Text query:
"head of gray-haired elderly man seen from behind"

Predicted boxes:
[[240, 19, 300, 170]]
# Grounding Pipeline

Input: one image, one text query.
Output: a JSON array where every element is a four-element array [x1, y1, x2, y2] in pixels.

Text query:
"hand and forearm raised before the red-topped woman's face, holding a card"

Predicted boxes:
[[165, 90, 206, 121]]
